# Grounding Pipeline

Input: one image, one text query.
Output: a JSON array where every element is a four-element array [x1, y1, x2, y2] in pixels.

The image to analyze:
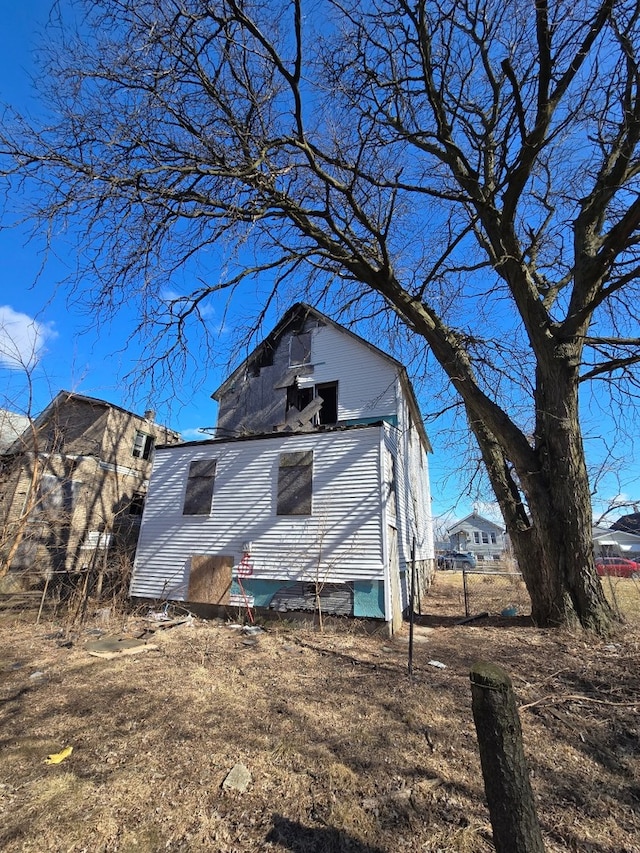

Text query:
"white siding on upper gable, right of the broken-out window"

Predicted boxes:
[[310, 326, 398, 421]]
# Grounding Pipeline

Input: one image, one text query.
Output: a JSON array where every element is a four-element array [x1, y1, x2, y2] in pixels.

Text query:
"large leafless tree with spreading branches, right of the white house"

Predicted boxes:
[[0, 0, 640, 632]]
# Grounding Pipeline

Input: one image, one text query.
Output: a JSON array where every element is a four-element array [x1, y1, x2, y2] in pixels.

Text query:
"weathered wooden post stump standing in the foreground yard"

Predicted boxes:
[[469, 661, 544, 853]]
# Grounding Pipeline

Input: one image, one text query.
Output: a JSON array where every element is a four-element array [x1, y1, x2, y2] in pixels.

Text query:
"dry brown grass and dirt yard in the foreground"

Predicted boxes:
[[0, 584, 640, 853]]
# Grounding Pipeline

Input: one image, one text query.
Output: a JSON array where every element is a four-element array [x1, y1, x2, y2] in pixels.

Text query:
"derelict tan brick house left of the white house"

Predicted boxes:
[[0, 391, 179, 586]]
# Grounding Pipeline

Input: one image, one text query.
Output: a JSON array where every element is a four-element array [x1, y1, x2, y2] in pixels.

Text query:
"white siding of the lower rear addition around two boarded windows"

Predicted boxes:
[[131, 427, 384, 600]]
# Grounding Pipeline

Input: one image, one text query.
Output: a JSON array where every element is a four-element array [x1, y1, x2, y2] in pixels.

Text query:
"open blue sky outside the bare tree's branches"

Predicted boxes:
[[0, 0, 640, 521]]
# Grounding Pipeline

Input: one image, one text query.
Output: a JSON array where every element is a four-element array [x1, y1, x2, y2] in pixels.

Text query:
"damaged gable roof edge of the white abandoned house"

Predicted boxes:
[[211, 302, 433, 453]]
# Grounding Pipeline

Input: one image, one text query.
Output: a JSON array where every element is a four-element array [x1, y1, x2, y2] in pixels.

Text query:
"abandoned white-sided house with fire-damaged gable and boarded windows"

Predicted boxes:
[[131, 303, 435, 630]]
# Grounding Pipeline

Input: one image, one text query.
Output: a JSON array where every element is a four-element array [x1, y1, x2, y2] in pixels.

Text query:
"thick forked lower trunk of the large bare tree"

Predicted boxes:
[[471, 346, 614, 635]]
